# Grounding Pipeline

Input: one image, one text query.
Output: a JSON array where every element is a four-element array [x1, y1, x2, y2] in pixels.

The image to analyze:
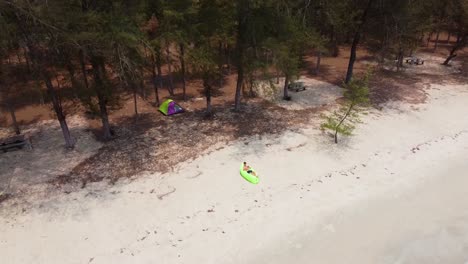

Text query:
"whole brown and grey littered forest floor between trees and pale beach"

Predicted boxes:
[[0, 43, 466, 204]]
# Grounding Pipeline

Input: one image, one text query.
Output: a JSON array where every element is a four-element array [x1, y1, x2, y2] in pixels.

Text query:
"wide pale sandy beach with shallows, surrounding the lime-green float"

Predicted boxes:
[[0, 85, 468, 264]]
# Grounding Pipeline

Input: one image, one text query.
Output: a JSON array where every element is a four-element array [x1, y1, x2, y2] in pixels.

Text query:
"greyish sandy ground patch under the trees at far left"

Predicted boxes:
[[0, 116, 102, 193]]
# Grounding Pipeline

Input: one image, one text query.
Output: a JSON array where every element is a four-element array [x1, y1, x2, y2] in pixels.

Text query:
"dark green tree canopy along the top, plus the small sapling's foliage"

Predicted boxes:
[[0, 0, 468, 131]]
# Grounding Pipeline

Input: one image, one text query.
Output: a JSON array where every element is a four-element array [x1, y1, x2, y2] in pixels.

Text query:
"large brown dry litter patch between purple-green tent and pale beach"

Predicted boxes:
[[52, 100, 317, 187]]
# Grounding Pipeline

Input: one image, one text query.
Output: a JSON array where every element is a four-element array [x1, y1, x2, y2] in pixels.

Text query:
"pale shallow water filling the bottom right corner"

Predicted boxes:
[[258, 159, 468, 264]]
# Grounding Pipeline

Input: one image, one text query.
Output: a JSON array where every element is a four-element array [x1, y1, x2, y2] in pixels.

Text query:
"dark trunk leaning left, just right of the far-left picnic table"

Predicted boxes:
[[42, 70, 75, 149]]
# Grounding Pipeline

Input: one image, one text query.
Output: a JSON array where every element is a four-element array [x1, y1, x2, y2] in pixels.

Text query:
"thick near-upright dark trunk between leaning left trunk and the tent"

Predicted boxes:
[[91, 56, 112, 140]]
